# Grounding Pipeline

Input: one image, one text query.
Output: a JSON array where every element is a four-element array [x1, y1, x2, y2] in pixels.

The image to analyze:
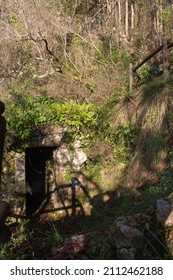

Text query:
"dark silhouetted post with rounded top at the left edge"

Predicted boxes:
[[0, 101, 6, 188]]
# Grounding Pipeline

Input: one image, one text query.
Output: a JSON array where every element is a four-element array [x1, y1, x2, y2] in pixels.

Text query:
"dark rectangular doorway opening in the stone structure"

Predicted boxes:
[[25, 147, 55, 216]]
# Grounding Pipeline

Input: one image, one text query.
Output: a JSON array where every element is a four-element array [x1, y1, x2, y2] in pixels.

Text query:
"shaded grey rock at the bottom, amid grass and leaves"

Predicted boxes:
[[110, 217, 144, 259]]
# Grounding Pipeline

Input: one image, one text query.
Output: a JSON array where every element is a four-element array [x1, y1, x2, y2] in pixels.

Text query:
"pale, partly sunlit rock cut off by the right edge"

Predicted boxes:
[[156, 193, 173, 226]]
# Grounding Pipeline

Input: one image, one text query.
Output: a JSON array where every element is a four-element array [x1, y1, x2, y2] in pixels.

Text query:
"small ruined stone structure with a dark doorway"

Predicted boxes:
[[6, 125, 87, 215]]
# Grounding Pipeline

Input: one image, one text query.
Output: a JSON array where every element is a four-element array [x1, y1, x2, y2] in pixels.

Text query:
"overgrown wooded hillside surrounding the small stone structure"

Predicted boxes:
[[0, 0, 173, 259]]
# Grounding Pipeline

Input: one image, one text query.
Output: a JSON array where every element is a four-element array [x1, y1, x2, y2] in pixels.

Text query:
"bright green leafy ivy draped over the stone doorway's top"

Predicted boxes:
[[7, 95, 96, 147]]
